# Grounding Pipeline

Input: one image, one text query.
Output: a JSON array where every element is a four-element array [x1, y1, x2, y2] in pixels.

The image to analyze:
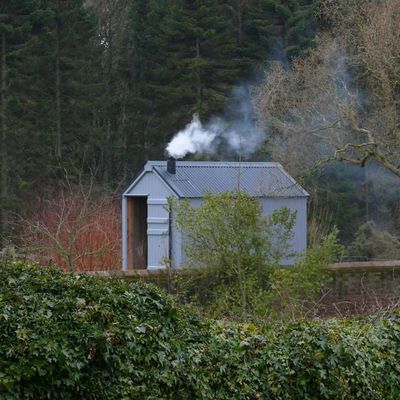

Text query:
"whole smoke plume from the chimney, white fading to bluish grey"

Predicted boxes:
[[166, 86, 265, 158]]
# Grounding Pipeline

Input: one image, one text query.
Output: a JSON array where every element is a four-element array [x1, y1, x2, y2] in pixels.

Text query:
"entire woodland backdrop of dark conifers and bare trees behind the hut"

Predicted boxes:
[[0, 0, 400, 258]]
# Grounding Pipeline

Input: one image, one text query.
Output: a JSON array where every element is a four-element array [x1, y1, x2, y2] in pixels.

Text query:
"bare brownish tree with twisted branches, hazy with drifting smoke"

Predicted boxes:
[[255, 0, 400, 176]]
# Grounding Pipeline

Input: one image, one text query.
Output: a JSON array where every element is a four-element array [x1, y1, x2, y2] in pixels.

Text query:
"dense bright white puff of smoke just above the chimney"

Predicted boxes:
[[167, 114, 217, 158]]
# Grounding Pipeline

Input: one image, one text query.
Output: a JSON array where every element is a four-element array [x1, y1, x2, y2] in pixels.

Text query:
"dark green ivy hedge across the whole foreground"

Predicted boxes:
[[0, 263, 400, 400]]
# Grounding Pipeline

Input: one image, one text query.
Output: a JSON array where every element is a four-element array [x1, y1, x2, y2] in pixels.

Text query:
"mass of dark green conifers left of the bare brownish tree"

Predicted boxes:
[[0, 0, 313, 239]]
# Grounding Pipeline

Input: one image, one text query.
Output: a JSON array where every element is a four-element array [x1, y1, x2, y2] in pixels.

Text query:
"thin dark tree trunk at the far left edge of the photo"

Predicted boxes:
[[0, 33, 9, 244]]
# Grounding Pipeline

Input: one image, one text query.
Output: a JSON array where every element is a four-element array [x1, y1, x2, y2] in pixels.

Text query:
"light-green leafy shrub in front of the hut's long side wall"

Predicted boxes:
[[171, 191, 296, 316]]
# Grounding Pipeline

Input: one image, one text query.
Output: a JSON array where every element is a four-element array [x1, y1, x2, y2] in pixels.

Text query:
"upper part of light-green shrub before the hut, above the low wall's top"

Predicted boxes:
[[170, 190, 296, 268]]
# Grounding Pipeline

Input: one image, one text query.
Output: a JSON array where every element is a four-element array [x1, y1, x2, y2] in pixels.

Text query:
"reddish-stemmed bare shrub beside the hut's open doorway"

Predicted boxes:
[[21, 188, 121, 271]]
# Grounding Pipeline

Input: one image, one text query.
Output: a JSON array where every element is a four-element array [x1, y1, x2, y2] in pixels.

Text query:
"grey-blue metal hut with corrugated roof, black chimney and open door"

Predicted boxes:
[[122, 160, 309, 270]]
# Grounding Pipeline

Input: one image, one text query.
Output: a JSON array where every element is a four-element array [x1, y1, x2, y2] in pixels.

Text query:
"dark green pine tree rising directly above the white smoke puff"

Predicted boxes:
[[169, 0, 240, 120]]
